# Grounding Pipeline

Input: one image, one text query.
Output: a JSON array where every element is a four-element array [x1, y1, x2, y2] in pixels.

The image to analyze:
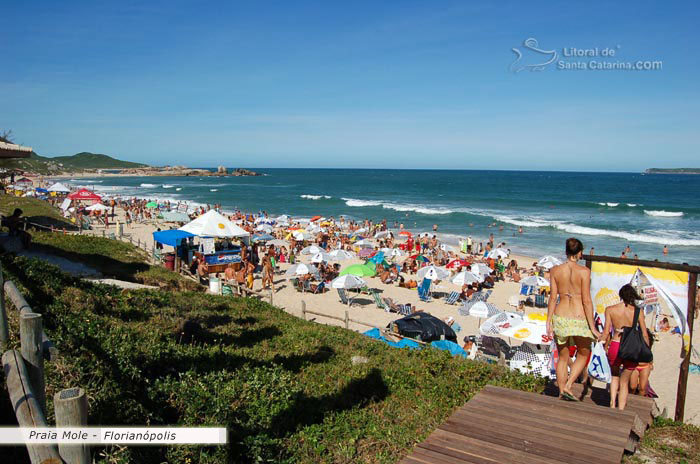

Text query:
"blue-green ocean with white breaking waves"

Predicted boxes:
[[69, 169, 700, 265]]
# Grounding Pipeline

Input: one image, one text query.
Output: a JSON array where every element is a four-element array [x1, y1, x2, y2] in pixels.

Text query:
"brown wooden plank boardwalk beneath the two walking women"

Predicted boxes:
[[401, 385, 653, 464]]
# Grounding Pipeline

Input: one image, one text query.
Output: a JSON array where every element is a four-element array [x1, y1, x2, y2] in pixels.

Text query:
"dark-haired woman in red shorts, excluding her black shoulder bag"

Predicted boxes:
[[603, 284, 651, 409]]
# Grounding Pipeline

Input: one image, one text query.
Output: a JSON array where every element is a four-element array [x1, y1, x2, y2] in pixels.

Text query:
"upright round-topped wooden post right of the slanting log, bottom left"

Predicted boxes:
[[53, 388, 92, 464]]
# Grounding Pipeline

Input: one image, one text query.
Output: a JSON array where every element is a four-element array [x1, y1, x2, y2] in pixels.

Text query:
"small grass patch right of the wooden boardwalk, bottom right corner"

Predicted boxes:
[[625, 419, 700, 464]]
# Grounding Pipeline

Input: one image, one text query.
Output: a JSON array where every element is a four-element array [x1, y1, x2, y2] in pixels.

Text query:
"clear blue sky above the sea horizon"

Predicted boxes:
[[0, 1, 700, 171]]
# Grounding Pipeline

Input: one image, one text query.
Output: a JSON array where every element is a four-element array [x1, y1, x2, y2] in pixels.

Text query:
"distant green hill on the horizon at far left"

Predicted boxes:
[[0, 152, 148, 174]]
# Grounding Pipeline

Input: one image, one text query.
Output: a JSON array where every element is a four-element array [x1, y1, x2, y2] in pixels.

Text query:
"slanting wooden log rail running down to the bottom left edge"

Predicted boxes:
[[2, 350, 63, 464]]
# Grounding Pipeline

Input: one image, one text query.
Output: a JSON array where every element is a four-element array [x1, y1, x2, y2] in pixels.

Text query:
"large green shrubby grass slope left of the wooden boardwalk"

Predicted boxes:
[[0, 245, 543, 463]]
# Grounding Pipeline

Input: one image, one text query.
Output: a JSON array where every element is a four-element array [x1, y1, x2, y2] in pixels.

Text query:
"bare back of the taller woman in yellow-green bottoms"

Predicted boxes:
[[550, 261, 591, 319]]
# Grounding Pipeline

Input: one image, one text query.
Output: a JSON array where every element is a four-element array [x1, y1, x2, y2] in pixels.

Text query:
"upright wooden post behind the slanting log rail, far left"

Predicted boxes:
[[19, 313, 46, 413]]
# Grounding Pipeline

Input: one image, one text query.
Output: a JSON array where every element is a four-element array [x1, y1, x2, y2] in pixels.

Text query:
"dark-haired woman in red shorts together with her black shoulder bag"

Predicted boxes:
[[603, 284, 653, 410]]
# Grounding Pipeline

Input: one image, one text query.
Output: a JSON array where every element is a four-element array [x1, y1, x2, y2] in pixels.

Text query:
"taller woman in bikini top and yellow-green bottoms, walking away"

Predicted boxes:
[[547, 237, 600, 401]]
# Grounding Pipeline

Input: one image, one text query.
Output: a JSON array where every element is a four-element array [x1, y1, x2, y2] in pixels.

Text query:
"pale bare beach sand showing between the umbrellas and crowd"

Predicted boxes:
[[78, 205, 700, 425]]
